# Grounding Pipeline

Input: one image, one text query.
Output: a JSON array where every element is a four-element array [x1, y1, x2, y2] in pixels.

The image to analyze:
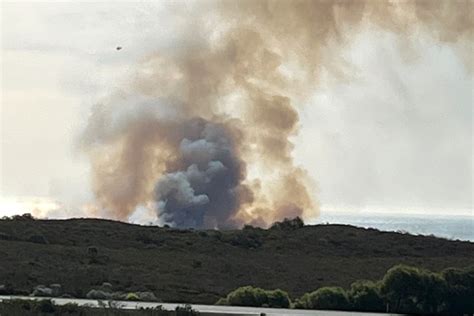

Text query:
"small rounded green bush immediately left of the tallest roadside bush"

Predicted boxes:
[[348, 281, 385, 312]]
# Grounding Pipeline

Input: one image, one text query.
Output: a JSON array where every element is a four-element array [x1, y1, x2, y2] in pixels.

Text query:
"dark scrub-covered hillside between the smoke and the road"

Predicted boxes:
[[0, 219, 474, 303]]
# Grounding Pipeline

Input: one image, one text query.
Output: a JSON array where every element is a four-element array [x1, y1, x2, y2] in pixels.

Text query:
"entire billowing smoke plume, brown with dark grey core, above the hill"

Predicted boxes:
[[82, 0, 473, 228]]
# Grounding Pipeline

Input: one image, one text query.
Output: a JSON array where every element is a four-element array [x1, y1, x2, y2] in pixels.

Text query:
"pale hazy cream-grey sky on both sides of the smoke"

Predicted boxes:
[[0, 2, 474, 220]]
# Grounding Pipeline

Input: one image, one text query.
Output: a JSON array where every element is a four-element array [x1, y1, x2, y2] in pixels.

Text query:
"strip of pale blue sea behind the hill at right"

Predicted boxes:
[[314, 212, 474, 241]]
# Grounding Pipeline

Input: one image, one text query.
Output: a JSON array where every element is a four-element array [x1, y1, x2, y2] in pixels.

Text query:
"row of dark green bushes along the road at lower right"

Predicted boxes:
[[216, 265, 474, 315]]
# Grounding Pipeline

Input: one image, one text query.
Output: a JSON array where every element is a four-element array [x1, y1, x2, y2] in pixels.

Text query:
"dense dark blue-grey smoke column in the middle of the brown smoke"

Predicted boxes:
[[155, 119, 245, 228]]
